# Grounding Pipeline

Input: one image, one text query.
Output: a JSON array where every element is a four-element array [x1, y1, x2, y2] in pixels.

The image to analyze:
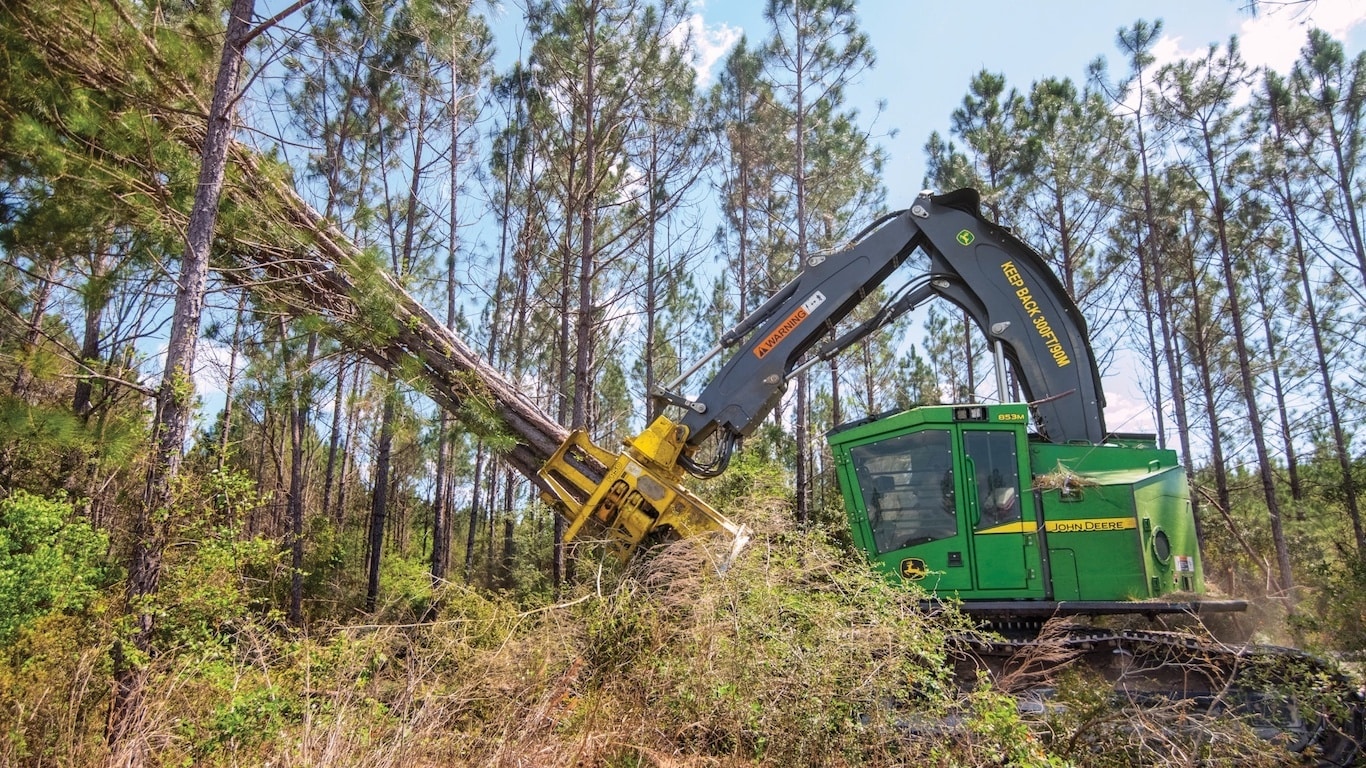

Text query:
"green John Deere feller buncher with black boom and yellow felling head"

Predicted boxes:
[[538, 190, 1361, 765]]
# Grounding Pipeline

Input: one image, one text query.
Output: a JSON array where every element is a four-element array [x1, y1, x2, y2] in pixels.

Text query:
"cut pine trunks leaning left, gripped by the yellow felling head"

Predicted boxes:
[[12, 0, 602, 519]]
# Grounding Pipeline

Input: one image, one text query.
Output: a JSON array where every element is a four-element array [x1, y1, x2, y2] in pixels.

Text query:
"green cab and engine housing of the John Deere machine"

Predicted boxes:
[[828, 403, 1205, 614]]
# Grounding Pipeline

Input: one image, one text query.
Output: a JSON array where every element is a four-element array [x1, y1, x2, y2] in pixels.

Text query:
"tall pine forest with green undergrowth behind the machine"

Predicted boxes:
[[0, 0, 1366, 765]]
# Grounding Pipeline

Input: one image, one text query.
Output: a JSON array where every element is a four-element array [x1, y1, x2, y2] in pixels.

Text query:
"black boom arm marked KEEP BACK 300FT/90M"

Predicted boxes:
[[672, 190, 1105, 456]]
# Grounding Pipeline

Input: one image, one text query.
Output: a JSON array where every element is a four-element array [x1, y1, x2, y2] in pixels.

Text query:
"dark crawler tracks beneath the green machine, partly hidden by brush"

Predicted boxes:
[[956, 615, 1366, 767]]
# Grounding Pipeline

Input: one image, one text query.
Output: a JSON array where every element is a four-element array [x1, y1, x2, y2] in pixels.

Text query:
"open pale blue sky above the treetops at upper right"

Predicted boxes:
[[693, 0, 1366, 209]]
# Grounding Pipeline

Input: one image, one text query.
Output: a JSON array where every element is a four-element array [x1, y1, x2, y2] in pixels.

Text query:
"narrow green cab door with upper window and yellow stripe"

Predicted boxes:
[[960, 425, 1044, 597]]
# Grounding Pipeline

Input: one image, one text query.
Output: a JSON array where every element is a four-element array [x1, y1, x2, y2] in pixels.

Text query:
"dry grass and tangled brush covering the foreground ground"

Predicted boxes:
[[0, 522, 1355, 768]]
